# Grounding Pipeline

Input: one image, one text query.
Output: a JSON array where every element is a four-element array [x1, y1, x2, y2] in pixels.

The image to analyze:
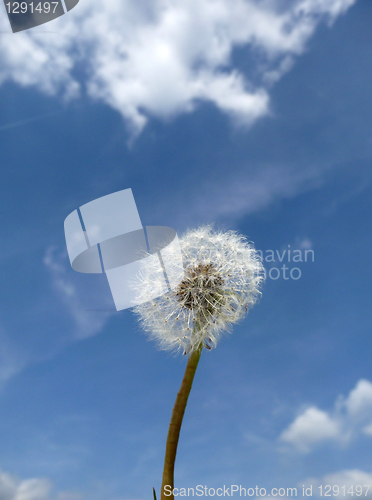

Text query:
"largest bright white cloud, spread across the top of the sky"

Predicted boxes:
[[0, 0, 355, 137]]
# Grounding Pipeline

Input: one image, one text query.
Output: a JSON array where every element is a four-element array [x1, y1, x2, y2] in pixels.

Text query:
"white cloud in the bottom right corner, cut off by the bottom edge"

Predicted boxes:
[[299, 469, 372, 498]]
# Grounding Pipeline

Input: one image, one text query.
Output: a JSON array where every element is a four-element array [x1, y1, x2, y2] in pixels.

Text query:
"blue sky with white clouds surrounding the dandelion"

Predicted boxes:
[[0, 0, 372, 500]]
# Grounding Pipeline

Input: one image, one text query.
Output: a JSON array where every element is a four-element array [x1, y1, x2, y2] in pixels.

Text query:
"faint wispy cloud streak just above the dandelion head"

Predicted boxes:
[[158, 160, 329, 226]]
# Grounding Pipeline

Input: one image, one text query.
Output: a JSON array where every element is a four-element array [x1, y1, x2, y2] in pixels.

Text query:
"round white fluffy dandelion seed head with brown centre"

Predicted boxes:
[[134, 226, 264, 354]]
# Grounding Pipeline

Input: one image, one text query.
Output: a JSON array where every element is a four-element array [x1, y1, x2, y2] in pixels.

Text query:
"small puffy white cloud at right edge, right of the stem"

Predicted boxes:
[[280, 379, 372, 452]]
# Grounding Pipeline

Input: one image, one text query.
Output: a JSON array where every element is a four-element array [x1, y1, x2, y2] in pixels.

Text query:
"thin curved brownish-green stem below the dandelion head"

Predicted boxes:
[[160, 345, 203, 500]]
